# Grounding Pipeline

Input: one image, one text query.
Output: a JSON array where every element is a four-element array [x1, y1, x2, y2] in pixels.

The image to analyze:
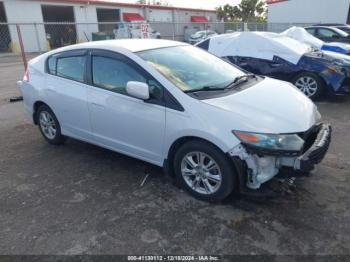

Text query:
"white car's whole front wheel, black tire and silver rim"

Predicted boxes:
[[174, 140, 237, 202]]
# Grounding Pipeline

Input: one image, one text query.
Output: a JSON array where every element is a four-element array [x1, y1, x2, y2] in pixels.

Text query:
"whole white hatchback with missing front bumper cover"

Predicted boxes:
[[17, 39, 331, 201]]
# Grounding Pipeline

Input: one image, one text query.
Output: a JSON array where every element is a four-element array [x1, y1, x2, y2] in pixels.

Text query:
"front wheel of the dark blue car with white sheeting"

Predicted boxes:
[[293, 72, 325, 99]]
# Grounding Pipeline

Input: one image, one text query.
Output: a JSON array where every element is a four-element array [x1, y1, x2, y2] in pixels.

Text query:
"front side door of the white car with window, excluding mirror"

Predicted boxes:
[[88, 50, 165, 164]]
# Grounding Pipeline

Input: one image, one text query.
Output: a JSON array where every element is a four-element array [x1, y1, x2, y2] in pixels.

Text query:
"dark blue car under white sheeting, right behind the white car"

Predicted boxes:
[[197, 32, 350, 99]]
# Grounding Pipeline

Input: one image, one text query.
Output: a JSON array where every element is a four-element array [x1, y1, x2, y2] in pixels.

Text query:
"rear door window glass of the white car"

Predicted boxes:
[[56, 56, 86, 82]]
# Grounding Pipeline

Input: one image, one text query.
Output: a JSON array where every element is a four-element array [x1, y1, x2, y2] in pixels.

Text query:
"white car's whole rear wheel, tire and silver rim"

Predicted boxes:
[[36, 105, 66, 145]]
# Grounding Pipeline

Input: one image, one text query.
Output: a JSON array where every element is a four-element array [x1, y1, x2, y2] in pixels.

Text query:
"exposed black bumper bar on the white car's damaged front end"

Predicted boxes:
[[294, 124, 332, 172]]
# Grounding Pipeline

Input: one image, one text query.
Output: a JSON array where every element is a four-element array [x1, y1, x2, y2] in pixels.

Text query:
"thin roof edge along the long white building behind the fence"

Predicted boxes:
[[39, 0, 216, 12]]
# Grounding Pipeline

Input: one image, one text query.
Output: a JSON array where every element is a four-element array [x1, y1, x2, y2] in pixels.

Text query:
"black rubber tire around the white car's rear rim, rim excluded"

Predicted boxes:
[[35, 105, 66, 145]]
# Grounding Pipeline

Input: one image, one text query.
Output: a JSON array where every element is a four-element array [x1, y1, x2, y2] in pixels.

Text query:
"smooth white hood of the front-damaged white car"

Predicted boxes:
[[202, 75, 317, 134]]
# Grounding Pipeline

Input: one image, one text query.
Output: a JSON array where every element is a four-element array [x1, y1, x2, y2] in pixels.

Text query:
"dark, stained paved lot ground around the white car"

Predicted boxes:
[[0, 53, 350, 255]]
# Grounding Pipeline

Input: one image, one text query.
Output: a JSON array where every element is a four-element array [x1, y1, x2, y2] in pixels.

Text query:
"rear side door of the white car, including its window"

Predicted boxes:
[[45, 50, 91, 140]]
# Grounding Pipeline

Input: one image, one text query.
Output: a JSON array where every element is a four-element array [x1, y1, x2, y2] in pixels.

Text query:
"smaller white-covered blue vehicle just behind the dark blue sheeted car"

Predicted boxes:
[[281, 26, 350, 55]]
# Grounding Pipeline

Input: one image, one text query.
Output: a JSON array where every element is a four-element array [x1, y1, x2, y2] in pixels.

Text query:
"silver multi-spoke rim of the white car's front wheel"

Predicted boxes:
[[181, 151, 222, 195]]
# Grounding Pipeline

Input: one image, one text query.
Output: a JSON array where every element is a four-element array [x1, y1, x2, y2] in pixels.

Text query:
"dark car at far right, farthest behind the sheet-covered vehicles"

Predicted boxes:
[[305, 26, 350, 44]]
